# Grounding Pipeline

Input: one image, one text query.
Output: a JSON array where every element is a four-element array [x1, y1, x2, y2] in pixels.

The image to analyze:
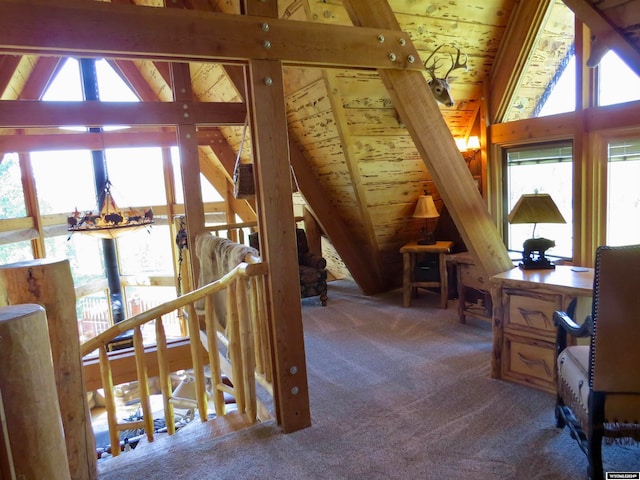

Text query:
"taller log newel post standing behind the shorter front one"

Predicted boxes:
[[0, 259, 98, 480]]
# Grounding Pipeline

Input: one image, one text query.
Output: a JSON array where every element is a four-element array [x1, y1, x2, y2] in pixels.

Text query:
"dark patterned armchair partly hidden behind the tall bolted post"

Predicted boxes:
[[249, 228, 327, 307]]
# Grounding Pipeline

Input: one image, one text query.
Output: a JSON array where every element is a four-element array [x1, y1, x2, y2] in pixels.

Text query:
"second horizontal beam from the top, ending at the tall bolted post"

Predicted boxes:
[[0, 99, 247, 128]]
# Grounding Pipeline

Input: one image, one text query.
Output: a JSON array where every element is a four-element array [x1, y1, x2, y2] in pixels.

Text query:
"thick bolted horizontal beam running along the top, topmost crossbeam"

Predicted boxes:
[[0, 0, 422, 71]]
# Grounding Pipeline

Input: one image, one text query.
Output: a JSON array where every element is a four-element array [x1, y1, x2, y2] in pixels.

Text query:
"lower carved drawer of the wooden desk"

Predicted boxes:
[[502, 335, 555, 392]]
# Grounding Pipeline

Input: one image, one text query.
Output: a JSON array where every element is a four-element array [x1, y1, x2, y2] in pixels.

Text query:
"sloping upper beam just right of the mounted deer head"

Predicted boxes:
[[488, 0, 553, 123]]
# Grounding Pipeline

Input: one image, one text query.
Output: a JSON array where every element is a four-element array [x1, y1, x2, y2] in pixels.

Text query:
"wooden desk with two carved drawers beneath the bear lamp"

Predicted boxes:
[[490, 265, 594, 393]]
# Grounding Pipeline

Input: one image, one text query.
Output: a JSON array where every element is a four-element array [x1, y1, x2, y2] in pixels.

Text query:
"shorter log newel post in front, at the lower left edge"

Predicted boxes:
[[0, 304, 71, 480]]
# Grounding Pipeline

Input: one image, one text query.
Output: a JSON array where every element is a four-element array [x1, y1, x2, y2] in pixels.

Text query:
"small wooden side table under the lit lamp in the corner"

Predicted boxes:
[[400, 240, 453, 308]]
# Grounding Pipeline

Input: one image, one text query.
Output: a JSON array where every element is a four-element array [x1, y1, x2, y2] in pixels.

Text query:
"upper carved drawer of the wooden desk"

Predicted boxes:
[[504, 291, 562, 338]]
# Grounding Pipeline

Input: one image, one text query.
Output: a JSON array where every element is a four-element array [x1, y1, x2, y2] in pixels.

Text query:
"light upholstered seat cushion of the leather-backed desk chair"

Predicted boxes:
[[558, 345, 589, 423]]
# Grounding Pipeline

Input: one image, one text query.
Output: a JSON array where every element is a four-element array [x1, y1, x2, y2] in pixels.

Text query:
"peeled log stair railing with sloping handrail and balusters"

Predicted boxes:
[[81, 257, 272, 456]]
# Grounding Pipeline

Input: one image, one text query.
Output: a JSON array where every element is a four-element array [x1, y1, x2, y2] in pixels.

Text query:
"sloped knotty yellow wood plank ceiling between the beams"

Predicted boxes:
[[0, 0, 640, 293]]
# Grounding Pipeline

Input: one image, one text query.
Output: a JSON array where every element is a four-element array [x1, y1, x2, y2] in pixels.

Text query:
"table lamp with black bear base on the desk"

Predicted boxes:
[[507, 193, 567, 270]]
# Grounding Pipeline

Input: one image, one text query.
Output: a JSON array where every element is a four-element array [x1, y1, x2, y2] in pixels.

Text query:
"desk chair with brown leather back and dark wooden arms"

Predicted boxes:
[[553, 245, 640, 480]]
